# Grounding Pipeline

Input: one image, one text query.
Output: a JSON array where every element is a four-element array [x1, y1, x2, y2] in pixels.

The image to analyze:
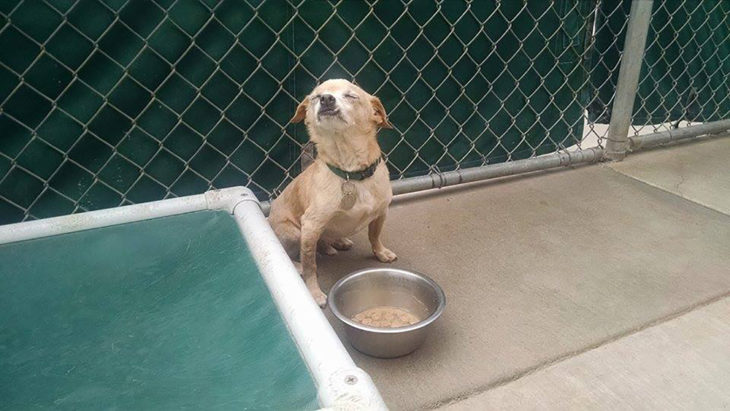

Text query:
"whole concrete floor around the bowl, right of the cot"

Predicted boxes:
[[318, 134, 730, 410]]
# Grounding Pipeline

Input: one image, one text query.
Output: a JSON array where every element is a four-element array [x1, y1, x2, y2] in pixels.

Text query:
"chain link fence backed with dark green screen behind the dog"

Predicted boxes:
[[0, 0, 730, 223]]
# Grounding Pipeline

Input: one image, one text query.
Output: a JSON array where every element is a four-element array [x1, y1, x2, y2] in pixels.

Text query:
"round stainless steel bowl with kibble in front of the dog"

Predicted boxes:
[[329, 268, 446, 358]]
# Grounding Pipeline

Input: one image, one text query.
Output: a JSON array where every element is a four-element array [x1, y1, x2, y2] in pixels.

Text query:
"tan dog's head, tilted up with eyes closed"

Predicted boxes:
[[291, 79, 393, 132]]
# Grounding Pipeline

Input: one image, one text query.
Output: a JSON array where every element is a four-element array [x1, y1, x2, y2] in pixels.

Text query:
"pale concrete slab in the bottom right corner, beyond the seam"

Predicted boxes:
[[445, 298, 730, 411]]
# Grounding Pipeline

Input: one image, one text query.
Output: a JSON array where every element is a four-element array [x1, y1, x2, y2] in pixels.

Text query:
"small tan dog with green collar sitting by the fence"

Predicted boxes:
[[269, 80, 397, 307]]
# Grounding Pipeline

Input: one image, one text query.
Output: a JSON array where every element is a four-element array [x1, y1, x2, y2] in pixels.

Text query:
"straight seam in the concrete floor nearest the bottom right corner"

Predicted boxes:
[[424, 291, 730, 410]]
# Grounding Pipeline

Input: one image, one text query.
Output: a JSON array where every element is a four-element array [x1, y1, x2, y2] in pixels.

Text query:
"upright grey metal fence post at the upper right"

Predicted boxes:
[[605, 0, 654, 160]]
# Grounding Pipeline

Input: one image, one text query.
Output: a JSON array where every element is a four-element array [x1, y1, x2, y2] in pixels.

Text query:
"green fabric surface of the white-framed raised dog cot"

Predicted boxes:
[[0, 212, 317, 410]]
